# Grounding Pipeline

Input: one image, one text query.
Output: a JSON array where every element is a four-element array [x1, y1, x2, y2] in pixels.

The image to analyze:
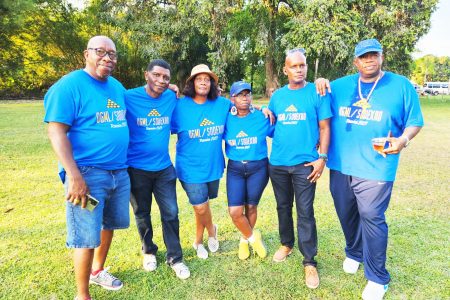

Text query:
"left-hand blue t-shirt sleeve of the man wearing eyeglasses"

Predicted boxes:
[[44, 78, 78, 126]]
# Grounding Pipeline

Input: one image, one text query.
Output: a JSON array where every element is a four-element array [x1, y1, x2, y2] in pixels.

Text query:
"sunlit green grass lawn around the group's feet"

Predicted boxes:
[[0, 97, 450, 299]]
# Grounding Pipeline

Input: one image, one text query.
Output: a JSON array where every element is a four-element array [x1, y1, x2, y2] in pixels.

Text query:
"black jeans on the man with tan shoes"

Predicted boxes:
[[269, 163, 317, 266]]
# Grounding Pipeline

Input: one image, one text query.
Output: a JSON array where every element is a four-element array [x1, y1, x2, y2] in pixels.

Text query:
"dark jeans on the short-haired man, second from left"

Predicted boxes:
[[128, 165, 183, 265]]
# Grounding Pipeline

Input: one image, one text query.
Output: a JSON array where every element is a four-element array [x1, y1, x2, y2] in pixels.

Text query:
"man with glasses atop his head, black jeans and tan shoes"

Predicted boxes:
[[269, 49, 332, 289]]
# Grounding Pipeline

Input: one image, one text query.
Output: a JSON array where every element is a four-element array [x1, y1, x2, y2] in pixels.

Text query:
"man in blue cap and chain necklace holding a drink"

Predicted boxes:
[[317, 39, 423, 299]]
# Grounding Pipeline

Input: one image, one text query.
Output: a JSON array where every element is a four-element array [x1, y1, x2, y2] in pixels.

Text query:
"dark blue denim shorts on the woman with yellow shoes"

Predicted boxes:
[[227, 158, 269, 206]]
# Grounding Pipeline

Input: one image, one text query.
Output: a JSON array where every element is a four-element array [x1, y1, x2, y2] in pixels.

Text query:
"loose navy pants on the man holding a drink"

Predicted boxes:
[[330, 170, 394, 285]]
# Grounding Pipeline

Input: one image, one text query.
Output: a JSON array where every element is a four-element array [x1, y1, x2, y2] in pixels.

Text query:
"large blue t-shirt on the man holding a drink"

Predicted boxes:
[[327, 72, 423, 181]]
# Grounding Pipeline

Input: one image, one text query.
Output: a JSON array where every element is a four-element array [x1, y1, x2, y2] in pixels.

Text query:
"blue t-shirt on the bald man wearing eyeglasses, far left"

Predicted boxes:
[[44, 70, 129, 170]]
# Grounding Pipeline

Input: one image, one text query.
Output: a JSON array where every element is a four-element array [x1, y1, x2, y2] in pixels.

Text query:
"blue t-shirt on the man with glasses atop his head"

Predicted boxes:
[[269, 83, 332, 166]]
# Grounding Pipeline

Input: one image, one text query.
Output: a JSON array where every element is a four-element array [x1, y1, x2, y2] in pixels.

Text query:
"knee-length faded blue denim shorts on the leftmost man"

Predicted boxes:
[[64, 167, 130, 249]]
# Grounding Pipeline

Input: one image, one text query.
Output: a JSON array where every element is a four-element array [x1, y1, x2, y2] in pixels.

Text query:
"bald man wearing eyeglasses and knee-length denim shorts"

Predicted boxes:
[[44, 36, 130, 300]]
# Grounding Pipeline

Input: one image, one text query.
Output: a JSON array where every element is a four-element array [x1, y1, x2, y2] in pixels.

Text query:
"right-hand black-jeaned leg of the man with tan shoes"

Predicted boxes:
[[293, 164, 317, 266]]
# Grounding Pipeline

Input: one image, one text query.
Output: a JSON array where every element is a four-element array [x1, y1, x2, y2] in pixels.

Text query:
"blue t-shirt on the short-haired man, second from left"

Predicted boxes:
[[125, 86, 177, 171]]
